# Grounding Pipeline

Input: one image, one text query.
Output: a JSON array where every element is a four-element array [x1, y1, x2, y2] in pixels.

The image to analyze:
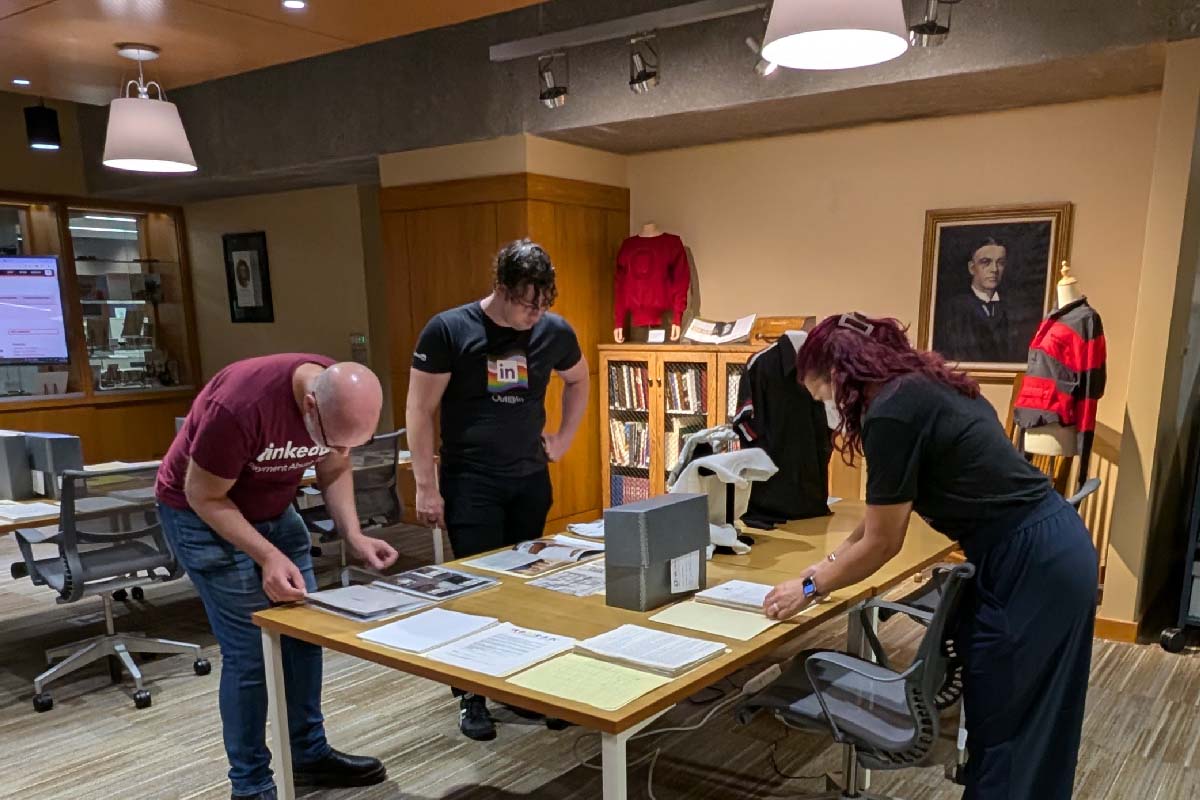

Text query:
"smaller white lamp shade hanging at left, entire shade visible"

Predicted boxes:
[[104, 97, 196, 173]]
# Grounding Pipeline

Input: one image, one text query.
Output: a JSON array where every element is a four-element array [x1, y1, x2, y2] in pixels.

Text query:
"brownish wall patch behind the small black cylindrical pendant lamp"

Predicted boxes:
[[0, 92, 86, 196]]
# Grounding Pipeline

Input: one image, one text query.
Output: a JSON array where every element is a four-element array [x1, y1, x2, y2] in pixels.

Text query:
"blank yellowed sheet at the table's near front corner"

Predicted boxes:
[[509, 652, 671, 711]]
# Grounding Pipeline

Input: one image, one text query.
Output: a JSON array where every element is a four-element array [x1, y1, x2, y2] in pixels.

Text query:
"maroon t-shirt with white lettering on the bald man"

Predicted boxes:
[[155, 353, 334, 522]]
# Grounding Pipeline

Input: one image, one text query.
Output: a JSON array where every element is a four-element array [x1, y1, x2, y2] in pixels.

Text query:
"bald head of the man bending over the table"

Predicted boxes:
[[304, 361, 383, 450]]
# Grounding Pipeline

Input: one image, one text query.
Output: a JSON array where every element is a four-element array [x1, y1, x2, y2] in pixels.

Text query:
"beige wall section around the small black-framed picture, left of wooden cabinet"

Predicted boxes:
[[184, 186, 367, 379]]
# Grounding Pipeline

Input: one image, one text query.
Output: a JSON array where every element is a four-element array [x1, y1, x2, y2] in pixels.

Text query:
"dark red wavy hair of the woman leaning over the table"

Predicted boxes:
[[796, 313, 979, 464]]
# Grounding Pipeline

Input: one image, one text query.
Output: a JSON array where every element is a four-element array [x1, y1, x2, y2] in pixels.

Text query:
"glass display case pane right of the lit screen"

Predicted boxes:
[[67, 207, 192, 392]]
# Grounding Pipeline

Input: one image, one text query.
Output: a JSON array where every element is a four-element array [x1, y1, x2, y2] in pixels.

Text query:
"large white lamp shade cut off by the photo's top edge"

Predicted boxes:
[[762, 0, 908, 70]]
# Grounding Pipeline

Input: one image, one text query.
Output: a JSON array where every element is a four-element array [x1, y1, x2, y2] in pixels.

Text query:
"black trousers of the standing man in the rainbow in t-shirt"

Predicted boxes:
[[440, 469, 554, 697]]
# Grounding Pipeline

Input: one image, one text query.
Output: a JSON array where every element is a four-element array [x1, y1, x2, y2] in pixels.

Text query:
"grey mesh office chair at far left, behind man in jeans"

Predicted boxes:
[[11, 467, 211, 711]]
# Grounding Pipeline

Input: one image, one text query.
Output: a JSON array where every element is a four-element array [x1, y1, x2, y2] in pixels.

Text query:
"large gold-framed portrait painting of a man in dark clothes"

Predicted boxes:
[[917, 203, 1072, 374]]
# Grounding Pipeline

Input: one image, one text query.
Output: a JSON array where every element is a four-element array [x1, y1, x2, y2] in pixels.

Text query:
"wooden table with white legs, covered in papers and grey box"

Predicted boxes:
[[253, 501, 953, 800]]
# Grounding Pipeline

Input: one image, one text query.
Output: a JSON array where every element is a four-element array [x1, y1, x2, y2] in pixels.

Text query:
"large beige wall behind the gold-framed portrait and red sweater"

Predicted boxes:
[[629, 94, 1159, 431]]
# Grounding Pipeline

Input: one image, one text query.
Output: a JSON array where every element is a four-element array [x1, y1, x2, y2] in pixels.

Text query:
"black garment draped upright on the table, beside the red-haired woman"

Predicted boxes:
[[733, 336, 833, 530]]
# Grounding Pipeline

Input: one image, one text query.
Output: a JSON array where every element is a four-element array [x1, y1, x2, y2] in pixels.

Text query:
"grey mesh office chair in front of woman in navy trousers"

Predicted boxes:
[[737, 564, 974, 800]]
